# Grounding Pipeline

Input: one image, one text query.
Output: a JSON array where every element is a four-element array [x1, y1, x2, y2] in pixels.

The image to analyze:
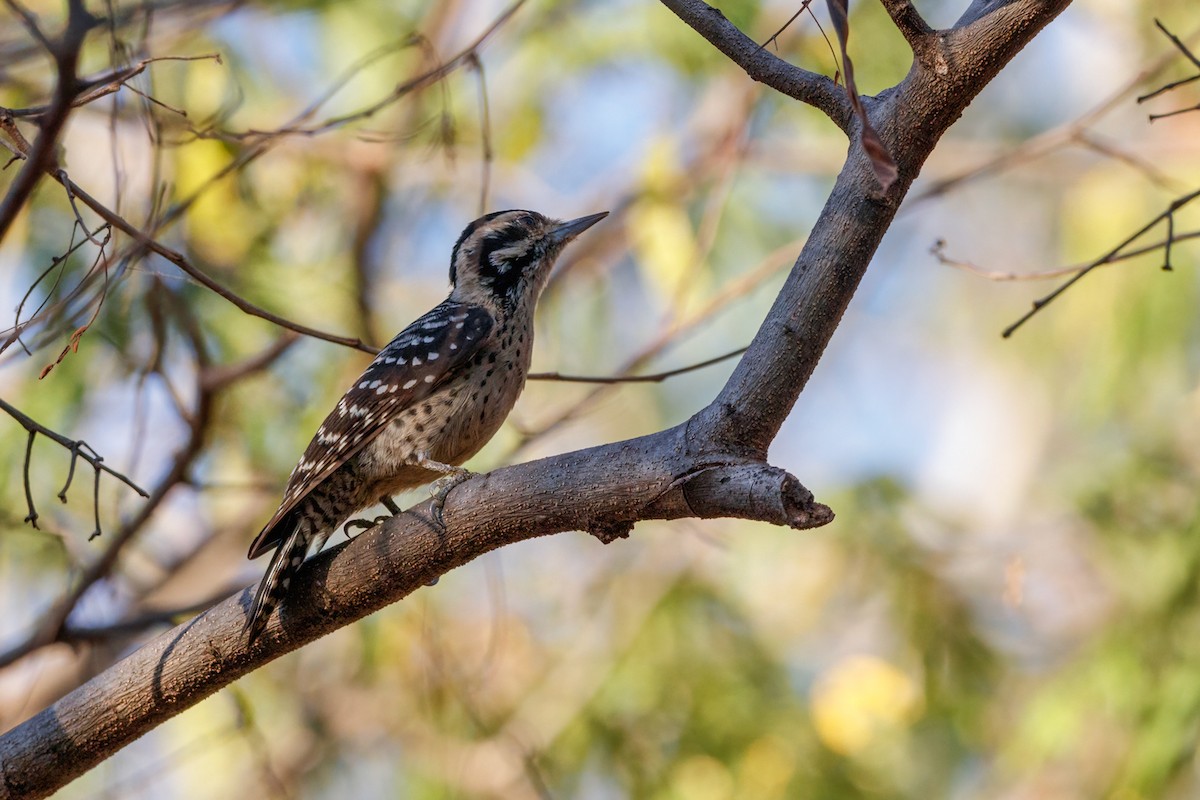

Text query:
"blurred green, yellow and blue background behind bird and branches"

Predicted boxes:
[[0, 0, 1200, 800]]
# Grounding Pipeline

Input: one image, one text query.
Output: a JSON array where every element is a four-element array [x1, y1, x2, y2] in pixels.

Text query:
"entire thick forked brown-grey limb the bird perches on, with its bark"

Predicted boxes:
[[0, 0, 1069, 798]]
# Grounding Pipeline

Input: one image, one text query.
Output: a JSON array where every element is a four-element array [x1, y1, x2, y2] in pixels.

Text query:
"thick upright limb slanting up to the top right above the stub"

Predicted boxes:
[[700, 0, 1070, 453]]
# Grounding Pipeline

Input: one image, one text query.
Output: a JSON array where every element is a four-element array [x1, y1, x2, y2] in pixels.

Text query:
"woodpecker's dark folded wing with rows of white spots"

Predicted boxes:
[[248, 300, 493, 559]]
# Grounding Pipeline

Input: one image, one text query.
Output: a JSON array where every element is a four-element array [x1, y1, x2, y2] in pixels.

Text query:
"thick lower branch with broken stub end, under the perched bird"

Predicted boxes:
[[0, 438, 833, 798]]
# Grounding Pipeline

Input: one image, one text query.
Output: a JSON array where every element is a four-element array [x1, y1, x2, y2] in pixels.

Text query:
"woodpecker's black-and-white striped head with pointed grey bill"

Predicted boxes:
[[450, 210, 607, 308]]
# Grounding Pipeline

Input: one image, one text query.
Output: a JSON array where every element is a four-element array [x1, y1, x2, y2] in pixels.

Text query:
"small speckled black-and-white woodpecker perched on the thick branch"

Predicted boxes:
[[244, 210, 608, 645]]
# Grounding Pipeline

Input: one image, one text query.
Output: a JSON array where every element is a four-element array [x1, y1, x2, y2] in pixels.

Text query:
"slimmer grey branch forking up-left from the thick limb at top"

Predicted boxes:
[[662, 0, 853, 132]]
